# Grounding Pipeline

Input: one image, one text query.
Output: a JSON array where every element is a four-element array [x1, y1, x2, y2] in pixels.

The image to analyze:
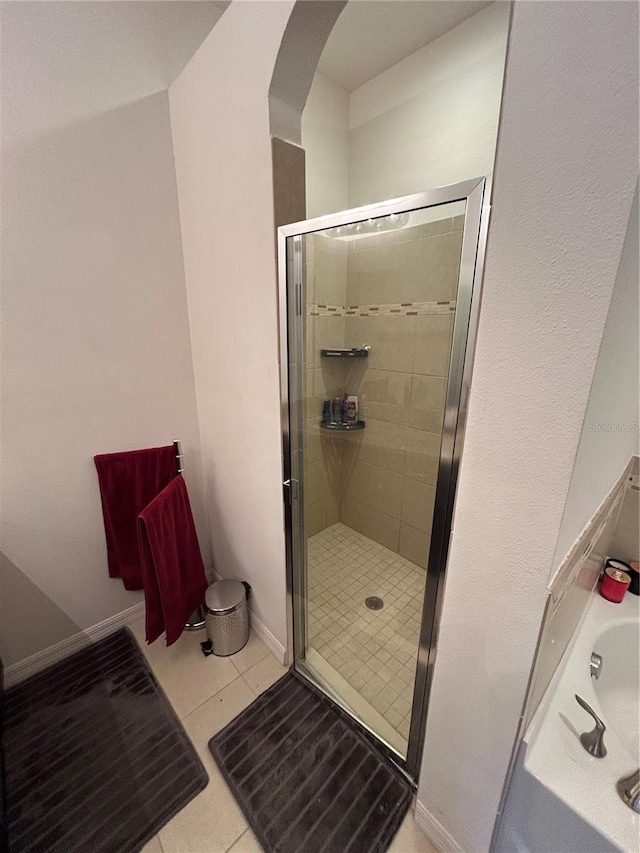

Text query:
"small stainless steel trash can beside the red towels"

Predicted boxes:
[[205, 580, 251, 657]]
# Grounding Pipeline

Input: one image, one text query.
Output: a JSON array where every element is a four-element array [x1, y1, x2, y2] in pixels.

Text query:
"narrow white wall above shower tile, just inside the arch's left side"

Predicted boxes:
[[302, 72, 349, 219]]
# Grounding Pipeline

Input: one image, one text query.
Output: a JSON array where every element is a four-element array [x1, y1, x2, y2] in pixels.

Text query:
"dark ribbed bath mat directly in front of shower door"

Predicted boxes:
[[209, 673, 412, 853]]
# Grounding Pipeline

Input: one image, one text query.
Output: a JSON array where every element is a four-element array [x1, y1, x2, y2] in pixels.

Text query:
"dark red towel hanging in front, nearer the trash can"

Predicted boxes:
[[138, 477, 208, 646]]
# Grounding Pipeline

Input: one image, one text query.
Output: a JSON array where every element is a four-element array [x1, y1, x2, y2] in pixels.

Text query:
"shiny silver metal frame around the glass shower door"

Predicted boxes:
[[278, 178, 489, 781]]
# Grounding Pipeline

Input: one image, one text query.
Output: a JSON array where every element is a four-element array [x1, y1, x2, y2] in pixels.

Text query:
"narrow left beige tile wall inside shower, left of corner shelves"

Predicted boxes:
[[303, 234, 347, 536]]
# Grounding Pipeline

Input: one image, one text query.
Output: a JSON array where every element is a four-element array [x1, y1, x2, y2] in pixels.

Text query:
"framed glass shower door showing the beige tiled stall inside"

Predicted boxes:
[[278, 179, 487, 779]]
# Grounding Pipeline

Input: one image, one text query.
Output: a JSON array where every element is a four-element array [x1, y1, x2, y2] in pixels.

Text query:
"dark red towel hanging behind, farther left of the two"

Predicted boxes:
[[94, 445, 177, 589]]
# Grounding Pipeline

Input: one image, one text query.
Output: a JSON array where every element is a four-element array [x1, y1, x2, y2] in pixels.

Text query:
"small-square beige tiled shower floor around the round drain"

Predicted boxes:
[[307, 522, 425, 741]]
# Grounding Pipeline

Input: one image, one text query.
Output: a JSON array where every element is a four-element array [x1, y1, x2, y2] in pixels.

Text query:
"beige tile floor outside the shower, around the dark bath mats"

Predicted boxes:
[[131, 619, 436, 853]]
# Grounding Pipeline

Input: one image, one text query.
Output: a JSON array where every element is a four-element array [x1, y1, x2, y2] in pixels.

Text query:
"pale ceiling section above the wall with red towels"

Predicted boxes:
[[0, 0, 229, 144]]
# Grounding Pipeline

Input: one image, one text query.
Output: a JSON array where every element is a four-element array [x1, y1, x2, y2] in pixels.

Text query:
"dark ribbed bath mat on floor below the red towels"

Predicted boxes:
[[4, 629, 209, 853]]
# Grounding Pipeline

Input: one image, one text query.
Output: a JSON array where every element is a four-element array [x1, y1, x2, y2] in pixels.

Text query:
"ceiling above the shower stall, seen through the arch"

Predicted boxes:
[[318, 0, 489, 92]]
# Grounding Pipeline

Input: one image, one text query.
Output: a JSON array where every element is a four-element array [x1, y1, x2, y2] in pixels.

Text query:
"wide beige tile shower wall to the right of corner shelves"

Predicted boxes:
[[340, 217, 463, 568]]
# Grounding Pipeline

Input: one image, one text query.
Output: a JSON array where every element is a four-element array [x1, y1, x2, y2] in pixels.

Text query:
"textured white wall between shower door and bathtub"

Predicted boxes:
[[418, 2, 638, 853]]
